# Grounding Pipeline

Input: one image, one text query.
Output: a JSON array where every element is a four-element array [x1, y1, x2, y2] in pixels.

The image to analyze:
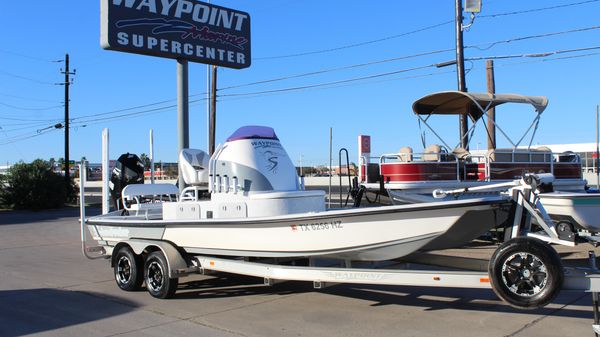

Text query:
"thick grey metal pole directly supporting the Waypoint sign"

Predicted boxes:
[[177, 59, 190, 191]]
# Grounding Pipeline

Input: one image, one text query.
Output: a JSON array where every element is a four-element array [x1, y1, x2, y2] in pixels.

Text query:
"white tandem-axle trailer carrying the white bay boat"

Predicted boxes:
[[80, 164, 600, 336]]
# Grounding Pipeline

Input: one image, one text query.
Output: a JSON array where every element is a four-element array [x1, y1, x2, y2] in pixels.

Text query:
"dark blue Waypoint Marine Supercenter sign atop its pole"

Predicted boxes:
[[100, 0, 251, 69]]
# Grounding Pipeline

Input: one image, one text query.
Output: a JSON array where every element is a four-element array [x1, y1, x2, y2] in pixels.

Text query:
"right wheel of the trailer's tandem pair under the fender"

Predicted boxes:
[[144, 251, 179, 299]]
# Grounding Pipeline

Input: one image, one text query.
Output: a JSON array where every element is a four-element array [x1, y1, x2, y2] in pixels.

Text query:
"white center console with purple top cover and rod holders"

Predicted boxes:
[[210, 126, 300, 193]]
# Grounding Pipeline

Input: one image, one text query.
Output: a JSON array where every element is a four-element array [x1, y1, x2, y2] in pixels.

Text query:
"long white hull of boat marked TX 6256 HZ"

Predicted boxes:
[[88, 198, 507, 261]]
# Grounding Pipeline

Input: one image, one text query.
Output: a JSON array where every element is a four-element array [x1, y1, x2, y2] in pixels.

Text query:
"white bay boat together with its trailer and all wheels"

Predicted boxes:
[[80, 127, 597, 316]]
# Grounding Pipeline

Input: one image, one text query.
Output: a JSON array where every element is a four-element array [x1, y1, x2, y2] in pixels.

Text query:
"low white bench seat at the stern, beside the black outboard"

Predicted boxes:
[[121, 184, 179, 215]]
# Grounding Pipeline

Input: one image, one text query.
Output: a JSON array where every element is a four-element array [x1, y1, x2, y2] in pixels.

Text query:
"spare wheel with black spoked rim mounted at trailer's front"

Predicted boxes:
[[488, 237, 564, 309]]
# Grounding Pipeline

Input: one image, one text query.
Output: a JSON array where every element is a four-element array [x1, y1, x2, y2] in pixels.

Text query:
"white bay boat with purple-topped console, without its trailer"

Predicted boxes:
[[87, 126, 510, 260]]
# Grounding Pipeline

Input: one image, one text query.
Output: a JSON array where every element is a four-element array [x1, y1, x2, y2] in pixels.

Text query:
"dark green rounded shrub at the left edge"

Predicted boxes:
[[0, 159, 77, 210]]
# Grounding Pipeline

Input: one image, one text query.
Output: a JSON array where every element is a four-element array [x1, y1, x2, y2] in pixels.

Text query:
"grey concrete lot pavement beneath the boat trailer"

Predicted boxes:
[[0, 208, 599, 336]]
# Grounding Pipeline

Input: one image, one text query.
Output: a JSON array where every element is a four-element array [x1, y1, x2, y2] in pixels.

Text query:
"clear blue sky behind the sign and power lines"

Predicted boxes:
[[0, 0, 600, 165]]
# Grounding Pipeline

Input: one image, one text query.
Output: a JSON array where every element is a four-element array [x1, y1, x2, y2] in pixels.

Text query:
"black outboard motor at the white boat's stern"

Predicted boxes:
[[108, 153, 144, 209]]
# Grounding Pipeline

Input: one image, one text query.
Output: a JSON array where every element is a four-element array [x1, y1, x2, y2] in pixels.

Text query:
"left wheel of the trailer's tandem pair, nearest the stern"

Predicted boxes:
[[113, 246, 144, 291]]
